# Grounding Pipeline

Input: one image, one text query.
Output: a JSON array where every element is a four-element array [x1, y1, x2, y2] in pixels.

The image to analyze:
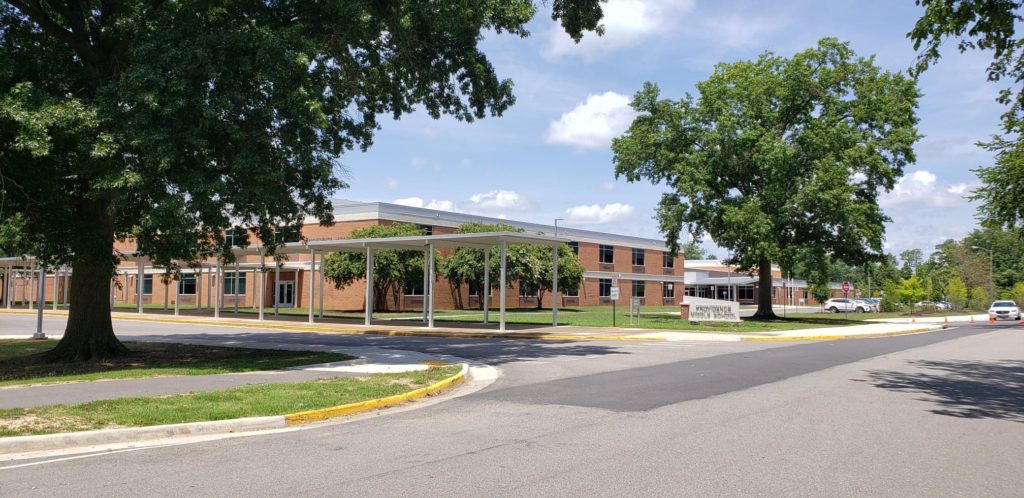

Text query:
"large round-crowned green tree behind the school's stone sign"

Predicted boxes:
[[612, 38, 920, 319]]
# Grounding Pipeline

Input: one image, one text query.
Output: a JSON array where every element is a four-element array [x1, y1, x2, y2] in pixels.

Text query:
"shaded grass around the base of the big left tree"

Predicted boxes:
[[0, 340, 354, 386]]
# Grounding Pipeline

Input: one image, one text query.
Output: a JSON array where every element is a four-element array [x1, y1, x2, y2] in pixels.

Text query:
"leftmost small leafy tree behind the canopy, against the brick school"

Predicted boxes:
[[324, 223, 423, 309]]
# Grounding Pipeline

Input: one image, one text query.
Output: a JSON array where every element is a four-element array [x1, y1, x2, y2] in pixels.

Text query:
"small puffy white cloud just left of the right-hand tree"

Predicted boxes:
[[545, 91, 636, 149]]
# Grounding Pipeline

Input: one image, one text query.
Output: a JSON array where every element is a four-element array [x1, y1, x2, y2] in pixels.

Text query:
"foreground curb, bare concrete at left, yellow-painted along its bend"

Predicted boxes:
[[0, 363, 469, 455]]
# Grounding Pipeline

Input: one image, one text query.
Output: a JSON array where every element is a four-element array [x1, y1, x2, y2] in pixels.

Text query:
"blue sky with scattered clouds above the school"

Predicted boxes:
[[337, 0, 1002, 260]]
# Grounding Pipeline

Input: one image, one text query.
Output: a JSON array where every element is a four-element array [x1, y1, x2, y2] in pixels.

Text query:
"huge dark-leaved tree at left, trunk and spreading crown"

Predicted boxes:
[[0, 0, 602, 360]]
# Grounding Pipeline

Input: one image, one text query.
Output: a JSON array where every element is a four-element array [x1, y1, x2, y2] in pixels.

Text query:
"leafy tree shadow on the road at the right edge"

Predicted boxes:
[[857, 360, 1024, 422]]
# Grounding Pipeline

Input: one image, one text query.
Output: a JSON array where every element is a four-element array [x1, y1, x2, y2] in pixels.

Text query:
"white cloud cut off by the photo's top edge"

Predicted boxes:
[[542, 0, 696, 59]]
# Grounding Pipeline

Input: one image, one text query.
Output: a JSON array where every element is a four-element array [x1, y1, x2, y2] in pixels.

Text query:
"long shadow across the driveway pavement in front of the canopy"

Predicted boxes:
[[121, 332, 629, 365]]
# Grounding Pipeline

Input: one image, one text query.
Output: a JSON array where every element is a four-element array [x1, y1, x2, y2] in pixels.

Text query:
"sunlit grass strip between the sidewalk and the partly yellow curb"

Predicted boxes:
[[0, 366, 461, 437]]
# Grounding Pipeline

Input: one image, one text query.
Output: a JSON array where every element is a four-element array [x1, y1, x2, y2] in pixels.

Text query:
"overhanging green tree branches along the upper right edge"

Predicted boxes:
[[907, 0, 1024, 226]]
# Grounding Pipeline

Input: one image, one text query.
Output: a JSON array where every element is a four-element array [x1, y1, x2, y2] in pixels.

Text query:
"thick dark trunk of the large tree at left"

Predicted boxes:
[[43, 201, 129, 362]]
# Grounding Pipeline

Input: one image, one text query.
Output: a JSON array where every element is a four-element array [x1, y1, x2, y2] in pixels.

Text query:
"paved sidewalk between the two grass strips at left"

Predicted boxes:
[[0, 344, 446, 409]]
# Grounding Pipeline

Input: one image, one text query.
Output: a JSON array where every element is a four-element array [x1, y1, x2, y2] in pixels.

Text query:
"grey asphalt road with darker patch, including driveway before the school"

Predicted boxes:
[[0, 317, 1024, 497]]
